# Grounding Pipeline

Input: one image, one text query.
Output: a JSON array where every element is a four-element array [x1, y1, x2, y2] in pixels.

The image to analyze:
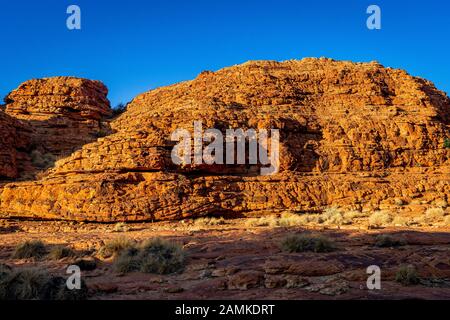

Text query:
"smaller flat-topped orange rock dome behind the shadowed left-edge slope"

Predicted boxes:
[[5, 77, 111, 155]]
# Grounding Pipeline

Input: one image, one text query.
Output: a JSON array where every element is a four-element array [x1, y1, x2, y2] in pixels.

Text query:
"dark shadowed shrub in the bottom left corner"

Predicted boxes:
[[0, 268, 87, 300]]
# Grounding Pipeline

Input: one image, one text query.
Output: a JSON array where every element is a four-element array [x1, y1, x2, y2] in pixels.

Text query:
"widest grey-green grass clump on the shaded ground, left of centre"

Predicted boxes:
[[114, 238, 185, 274]]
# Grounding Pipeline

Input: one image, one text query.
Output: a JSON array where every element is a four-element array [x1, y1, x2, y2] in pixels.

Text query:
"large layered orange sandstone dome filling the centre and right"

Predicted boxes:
[[0, 59, 450, 222]]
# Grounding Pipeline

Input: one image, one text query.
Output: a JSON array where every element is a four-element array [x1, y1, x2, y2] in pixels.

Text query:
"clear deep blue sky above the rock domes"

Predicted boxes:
[[0, 0, 450, 106]]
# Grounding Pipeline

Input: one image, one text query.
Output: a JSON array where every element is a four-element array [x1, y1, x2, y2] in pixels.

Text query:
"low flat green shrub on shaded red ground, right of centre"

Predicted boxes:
[[281, 235, 336, 252]]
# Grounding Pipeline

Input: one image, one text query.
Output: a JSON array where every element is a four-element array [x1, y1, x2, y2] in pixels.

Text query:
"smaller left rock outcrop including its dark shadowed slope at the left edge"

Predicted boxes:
[[0, 77, 111, 178]]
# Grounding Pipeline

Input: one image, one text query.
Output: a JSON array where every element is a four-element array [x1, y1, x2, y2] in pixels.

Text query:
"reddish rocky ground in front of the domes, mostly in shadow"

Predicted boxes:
[[0, 210, 450, 299]]
